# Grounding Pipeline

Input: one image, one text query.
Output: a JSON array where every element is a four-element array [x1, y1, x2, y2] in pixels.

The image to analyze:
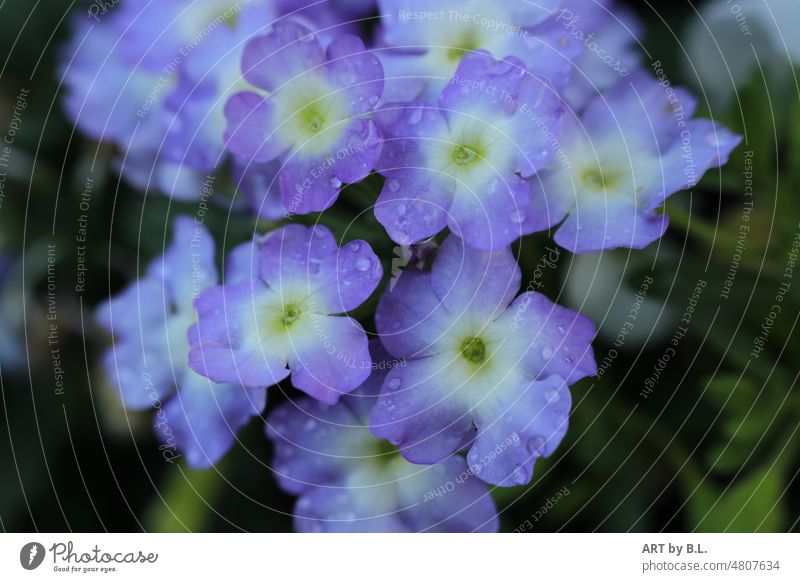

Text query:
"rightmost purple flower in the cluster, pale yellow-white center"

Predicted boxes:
[[526, 71, 741, 253]]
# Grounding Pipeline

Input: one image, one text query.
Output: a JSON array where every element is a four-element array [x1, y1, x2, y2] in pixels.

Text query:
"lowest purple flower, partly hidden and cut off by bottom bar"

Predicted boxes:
[[267, 340, 498, 532]]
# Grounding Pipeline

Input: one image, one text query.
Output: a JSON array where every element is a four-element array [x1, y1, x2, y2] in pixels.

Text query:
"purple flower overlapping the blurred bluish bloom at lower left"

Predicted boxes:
[[189, 225, 383, 404]]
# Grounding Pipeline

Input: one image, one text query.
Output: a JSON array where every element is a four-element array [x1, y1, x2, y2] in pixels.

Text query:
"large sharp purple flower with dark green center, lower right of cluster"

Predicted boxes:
[[370, 236, 597, 486]]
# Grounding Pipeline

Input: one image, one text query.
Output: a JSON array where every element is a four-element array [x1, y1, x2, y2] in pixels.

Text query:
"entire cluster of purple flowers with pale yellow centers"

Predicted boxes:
[[70, 0, 740, 531]]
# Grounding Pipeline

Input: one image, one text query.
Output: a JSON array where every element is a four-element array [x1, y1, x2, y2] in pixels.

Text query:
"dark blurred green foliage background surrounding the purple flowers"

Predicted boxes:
[[0, 0, 800, 532]]
